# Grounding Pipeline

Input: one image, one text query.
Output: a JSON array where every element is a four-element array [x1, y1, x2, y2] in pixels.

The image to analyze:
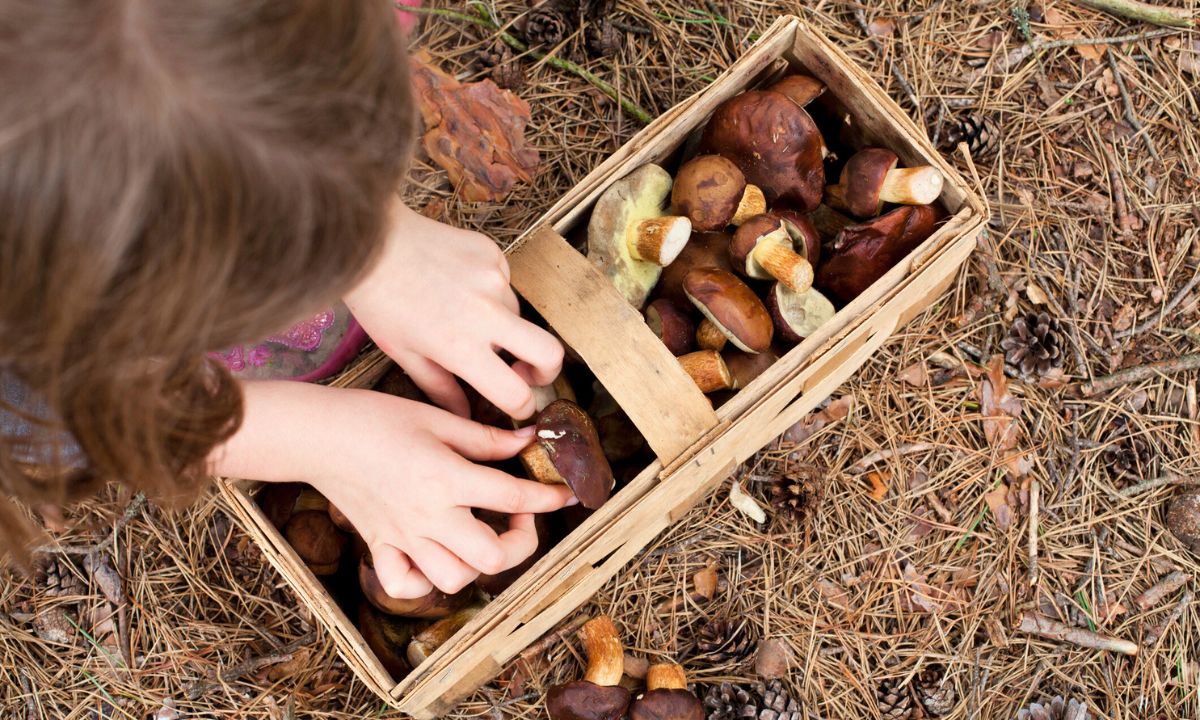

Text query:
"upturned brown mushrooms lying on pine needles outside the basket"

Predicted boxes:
[[546, 616, 706, 720]]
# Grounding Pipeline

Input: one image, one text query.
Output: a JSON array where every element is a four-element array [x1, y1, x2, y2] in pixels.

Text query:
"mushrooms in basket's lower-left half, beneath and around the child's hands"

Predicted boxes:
[[257, 366, 644, 679]]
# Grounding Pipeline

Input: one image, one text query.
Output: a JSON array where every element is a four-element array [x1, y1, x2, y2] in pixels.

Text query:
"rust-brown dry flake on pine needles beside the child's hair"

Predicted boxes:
[[413, 53, 539, 203]]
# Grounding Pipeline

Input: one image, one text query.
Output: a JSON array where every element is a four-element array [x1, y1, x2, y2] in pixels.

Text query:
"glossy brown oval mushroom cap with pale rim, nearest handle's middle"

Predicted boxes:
[[683, 268, 774, 353]]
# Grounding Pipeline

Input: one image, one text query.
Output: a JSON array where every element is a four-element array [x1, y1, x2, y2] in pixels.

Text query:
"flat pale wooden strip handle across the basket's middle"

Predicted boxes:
[[509, 226, 718, 464]]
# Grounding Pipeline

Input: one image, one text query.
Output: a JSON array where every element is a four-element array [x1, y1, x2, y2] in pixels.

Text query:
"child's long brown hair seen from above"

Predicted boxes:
[[0, 0, 414, 553]]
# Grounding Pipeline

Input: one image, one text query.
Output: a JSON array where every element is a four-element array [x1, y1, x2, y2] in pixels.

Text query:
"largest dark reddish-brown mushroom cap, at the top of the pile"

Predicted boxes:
[[700, 90, 824, 212]]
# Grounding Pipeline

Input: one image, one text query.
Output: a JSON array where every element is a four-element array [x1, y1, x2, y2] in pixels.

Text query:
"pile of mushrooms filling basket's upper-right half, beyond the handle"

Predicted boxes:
[[587, 74, 946, 401]]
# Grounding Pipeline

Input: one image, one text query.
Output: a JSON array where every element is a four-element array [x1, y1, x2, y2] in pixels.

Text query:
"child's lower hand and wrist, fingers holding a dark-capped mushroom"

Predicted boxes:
[[215, 382, 572, 598]]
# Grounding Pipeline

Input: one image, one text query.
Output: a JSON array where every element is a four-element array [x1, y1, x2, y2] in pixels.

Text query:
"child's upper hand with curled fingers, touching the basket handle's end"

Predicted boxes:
[[346, 203, 563, 419]]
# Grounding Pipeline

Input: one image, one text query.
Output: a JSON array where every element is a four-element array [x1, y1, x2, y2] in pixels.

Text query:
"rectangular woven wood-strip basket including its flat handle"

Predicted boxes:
[[221, 17, 986, 719]]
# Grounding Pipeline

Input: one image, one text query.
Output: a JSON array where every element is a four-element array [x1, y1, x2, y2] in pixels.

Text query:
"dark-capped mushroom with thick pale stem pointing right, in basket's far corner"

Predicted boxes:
[[826, 148, 943, 217]]
